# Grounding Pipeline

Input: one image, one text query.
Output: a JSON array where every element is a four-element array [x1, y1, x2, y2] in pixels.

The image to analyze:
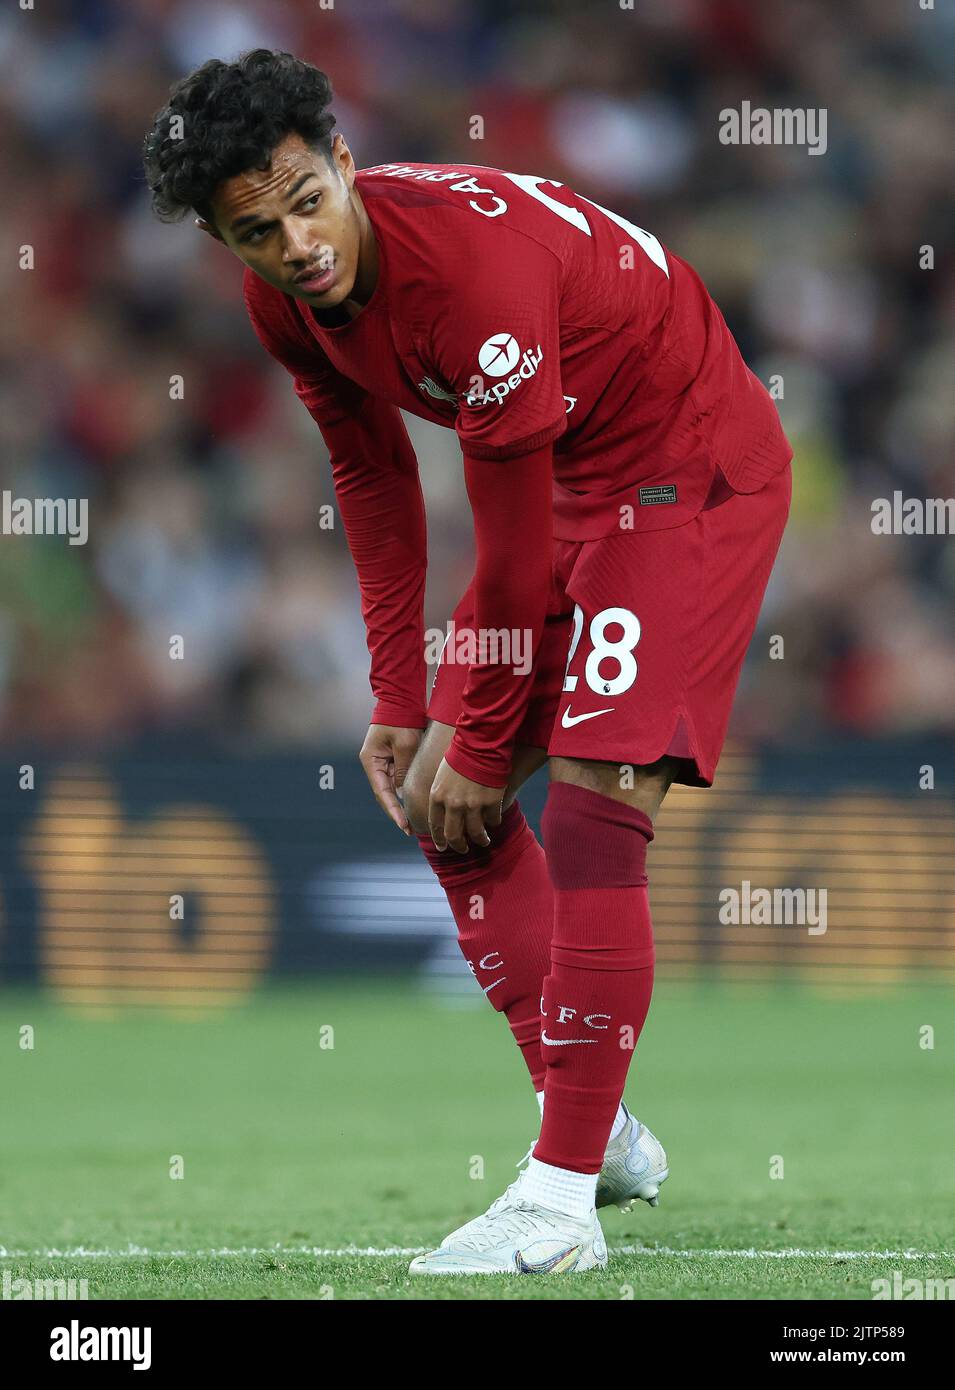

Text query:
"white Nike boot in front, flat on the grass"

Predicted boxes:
[[409, 1177, 607, 1275]]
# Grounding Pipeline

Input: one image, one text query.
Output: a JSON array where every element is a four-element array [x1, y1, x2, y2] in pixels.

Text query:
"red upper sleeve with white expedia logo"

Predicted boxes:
[[425, 227, 567, 459]]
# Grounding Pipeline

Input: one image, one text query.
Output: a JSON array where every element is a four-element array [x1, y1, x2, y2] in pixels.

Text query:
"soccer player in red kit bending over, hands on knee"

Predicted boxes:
[[145, 49, 791, 1273]]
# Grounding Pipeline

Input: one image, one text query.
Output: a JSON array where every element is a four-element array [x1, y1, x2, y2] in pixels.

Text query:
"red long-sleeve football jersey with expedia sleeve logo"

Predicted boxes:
[[245, 164, 791, 787]]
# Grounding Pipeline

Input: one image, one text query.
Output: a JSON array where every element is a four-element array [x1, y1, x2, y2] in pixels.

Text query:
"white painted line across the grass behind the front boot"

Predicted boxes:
[[0, 1245, 955, 1259]]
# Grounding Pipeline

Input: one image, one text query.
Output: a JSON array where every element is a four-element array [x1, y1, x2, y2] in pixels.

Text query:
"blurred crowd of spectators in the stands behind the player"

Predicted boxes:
[[0, 0, 955, 748]]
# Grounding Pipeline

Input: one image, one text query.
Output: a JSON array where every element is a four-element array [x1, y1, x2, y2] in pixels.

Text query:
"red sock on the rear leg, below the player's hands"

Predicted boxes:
[[418, 801, 553, 1091]]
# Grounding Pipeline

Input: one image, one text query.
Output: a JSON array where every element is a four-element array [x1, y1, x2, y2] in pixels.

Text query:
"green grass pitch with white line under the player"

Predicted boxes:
[[0, 981, 955, 1300]]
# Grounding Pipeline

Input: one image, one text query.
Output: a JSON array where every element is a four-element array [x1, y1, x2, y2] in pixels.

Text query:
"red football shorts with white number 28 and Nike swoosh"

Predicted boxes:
[[428, 466, 792, 787]]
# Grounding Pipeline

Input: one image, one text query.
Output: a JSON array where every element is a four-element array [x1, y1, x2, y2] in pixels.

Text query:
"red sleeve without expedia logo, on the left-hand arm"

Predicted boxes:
[[245, 271, 428, 728]]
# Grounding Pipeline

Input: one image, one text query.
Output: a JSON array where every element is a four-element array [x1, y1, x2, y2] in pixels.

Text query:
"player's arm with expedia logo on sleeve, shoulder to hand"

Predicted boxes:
[[427, 227, 566, 851]]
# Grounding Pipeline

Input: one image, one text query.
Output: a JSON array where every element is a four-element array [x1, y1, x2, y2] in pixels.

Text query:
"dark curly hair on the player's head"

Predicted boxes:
[[143, 49, 335, 222]]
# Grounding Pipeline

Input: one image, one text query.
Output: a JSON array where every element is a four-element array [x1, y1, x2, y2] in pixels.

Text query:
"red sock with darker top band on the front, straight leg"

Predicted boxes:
[[534, 783, 653, 1173]]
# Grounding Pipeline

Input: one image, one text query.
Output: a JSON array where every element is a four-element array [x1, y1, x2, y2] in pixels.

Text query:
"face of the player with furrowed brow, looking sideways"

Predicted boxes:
[[199, 133, 367, 309]]
